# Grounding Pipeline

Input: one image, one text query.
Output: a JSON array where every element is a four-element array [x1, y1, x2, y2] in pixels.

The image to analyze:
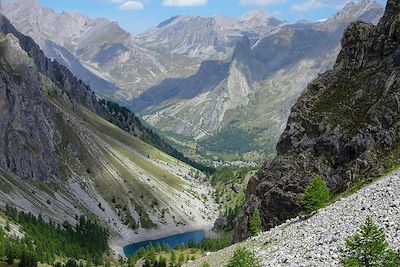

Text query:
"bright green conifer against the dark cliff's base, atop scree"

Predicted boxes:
[[300, 176, 330, 214]]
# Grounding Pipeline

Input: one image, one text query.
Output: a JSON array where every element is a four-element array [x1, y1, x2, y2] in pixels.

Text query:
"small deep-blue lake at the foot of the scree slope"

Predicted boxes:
[[124, 230, 206, 257]]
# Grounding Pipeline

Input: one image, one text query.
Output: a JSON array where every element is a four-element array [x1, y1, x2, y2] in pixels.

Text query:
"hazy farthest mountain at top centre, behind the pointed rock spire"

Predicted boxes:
[[139, 11, 285, 60]]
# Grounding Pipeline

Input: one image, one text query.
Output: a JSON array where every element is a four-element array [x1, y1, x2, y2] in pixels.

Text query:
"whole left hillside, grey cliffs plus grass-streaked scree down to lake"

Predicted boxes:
[[0, 12, 217, 255]]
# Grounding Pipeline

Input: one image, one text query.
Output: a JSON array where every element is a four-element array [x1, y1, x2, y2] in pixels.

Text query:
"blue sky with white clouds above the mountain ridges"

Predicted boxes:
[[39, 0, 386, 34]]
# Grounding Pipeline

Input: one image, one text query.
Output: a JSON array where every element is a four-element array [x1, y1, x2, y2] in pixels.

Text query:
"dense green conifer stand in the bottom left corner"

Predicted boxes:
[[0, 206, 108, 266]]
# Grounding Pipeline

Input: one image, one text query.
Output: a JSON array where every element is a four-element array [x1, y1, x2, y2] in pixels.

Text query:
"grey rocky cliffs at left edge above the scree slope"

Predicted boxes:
[[0, 12, 98, 180]]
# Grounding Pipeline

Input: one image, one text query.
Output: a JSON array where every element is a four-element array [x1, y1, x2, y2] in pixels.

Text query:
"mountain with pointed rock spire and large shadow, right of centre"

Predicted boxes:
[[131, 1, 383, 163]]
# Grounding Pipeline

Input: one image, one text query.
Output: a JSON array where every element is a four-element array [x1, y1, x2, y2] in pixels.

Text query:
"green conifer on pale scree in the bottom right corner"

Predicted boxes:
[[340, 217, 400, 267]]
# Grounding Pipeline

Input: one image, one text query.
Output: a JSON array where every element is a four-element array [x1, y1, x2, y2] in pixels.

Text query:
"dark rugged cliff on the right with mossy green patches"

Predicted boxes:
[[235, 0, 400, 241]]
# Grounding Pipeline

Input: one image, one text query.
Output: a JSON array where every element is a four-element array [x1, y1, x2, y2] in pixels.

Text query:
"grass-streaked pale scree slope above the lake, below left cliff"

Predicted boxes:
[[0, 81, 219, 249]]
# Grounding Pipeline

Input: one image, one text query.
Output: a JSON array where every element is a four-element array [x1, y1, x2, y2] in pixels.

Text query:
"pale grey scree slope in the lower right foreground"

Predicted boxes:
[[186, 171, 400, 267]]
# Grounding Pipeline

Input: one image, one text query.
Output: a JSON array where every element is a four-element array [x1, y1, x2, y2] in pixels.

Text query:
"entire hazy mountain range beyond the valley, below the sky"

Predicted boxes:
[[0, 0, 383, 162]]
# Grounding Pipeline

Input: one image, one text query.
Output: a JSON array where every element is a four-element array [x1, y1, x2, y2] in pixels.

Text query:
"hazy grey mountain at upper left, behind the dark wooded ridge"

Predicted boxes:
[[1, 0, 197, 99]]
